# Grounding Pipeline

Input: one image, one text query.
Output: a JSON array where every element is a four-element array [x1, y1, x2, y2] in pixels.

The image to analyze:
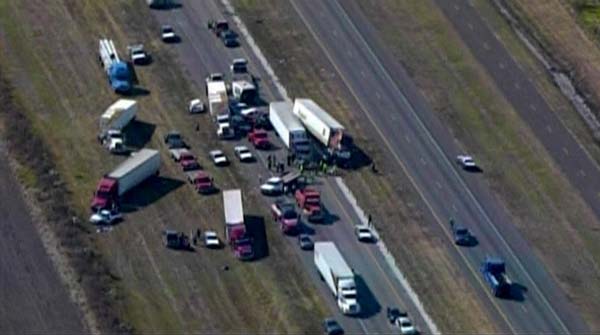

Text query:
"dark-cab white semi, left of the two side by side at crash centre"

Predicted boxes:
[[269, 101, 310, 158]]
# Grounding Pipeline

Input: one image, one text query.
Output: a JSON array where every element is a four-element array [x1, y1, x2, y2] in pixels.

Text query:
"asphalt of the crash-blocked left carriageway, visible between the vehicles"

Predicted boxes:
[[149, 1, 429, 333]]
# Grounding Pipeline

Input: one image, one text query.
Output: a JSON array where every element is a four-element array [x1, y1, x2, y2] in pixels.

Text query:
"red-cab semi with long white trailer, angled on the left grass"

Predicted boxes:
[[90, 149, 160, 212]]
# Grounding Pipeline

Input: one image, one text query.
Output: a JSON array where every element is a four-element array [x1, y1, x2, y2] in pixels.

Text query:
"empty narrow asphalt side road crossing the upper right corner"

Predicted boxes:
[[436, 0, 600, 224]]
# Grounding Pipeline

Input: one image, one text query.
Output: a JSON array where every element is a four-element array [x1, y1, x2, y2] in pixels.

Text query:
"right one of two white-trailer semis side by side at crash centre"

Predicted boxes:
[[292, 99, 350, 161]]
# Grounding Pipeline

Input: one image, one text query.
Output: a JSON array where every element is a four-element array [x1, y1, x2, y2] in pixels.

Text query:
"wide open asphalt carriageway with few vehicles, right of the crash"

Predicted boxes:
[[290, 0, 587, 333]]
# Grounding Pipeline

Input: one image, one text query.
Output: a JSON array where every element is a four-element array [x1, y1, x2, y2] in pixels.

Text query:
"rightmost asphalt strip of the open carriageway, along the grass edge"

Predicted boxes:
[[338, 1, 585, 332]]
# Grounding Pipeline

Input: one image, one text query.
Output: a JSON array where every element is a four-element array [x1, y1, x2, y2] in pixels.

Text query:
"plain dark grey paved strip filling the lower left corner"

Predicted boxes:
[[0, 143, 86, 334]]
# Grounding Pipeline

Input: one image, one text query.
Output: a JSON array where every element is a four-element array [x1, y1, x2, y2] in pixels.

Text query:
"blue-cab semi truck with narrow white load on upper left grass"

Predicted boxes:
[[98, 38, 133, 94]]
